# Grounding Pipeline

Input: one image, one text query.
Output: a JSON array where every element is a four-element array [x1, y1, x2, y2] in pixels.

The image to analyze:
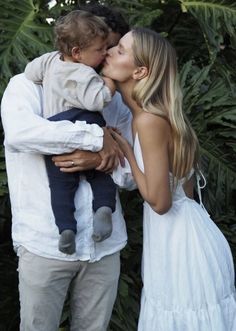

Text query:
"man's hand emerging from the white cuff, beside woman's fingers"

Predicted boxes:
[[96, 128, 124, 173]]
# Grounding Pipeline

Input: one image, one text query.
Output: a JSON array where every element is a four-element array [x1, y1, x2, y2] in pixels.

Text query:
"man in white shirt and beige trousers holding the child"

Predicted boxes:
[[2, 8, 131, 331]]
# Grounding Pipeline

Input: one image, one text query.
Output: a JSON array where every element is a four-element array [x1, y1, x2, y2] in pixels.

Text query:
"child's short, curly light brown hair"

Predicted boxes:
[[54, 10, 109, 56]]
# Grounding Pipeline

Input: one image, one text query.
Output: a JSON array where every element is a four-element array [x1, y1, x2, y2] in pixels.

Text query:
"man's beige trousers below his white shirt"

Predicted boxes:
[[18, 247, 120, 331]]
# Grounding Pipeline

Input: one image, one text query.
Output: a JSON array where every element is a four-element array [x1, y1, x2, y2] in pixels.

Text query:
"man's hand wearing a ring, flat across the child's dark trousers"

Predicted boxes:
[[52, 150, 101, 172]]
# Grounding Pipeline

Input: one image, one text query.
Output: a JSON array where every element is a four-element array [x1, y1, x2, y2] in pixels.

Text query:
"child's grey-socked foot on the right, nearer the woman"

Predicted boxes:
[[92, 207, 112, 242]]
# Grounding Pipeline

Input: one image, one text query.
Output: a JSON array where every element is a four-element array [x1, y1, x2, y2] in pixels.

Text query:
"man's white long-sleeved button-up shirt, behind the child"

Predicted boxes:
[[1, 74, 131, 261]]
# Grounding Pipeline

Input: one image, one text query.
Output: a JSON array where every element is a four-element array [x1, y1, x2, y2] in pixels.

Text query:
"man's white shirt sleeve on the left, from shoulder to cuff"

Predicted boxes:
[[1, 74, 103, 154]]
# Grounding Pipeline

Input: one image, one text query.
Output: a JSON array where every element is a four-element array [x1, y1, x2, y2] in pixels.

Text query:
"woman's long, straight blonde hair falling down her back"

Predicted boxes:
[[132, 28, 199, 180]]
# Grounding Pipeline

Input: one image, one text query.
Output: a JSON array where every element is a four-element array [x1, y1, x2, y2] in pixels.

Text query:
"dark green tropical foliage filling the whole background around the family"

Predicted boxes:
[[0, 0, 236, 331]]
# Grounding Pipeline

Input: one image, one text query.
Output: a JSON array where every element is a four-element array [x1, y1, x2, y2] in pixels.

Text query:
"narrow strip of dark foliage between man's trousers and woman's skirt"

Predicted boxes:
[[109, 191, 142, 331]]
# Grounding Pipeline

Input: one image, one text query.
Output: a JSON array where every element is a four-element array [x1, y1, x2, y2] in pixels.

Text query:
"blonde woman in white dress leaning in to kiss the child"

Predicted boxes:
[[103, 29, 236, 331]]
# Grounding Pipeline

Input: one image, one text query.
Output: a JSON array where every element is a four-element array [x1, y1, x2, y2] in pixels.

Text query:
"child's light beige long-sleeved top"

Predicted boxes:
[[25, 52, 112, 118]]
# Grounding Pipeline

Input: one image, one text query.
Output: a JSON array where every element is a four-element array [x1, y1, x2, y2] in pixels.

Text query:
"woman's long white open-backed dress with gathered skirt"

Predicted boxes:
[[134, 135, 236, 331]]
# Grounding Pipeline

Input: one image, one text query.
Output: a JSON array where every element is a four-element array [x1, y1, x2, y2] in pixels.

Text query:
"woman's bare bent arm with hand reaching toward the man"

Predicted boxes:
[[112, 113, 172, 214]]
